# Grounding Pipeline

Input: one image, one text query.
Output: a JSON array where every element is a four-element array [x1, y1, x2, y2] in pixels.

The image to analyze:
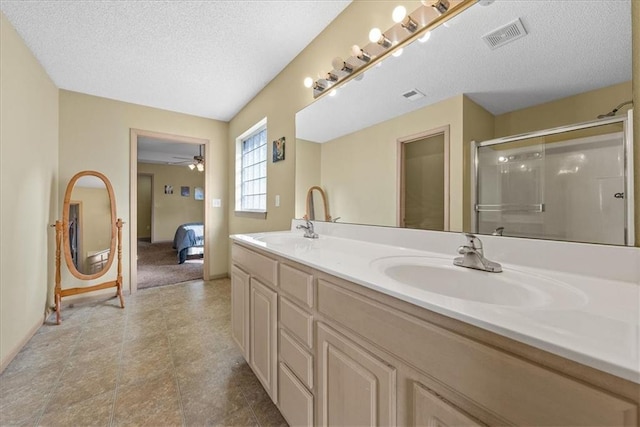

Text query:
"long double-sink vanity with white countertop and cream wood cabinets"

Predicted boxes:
[[231, 221, 640, 426]]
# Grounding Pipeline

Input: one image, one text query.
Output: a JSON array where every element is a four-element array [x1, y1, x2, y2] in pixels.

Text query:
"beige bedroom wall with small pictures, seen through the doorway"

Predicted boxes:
[[138, 163, 204, 242]]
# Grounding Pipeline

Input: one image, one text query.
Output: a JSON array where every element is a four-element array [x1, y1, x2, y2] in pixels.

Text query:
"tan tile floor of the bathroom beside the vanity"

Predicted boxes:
[[0, 279, 286, 426]]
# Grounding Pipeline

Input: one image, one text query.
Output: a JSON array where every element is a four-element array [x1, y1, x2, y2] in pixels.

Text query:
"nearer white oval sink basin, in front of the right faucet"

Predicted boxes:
[[371, 256, 586, 308]]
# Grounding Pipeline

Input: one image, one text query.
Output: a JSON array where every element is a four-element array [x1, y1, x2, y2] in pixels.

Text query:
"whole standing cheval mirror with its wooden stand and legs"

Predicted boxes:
[[55, 171, 124, 324]]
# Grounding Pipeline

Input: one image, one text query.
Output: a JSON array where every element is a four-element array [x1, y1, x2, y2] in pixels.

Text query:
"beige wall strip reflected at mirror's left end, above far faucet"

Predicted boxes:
[[295, 139, 322, 218]]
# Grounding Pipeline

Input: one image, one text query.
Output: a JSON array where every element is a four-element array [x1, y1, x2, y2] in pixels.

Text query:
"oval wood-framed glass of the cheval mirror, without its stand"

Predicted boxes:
[[63, 172, 115, 279]]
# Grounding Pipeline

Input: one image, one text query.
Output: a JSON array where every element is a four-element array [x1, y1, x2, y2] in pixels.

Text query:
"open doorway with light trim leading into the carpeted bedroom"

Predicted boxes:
[[129, 129, 209, 293]]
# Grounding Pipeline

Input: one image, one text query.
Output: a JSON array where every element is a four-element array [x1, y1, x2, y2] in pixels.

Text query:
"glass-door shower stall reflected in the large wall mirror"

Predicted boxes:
[[471, 112, 634, 246]]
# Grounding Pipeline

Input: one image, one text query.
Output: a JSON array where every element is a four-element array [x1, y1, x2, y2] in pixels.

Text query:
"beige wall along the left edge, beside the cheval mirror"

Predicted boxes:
[[0, 13, 60, 371]]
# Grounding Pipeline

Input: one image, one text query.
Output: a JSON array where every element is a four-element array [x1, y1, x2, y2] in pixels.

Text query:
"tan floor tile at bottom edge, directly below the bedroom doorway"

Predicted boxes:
[[114, 372, 183, 426]]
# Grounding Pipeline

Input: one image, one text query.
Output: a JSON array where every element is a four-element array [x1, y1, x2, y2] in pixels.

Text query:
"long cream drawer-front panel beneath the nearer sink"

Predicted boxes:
[[317, 279, 638, 426]]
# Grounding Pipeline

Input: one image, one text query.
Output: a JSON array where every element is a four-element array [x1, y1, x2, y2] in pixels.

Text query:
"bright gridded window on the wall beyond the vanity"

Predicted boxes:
[[236, 118, 267, 217]]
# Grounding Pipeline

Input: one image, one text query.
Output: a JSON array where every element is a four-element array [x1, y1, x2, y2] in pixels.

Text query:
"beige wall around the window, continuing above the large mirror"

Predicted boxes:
[[228, 0, 402, 237]]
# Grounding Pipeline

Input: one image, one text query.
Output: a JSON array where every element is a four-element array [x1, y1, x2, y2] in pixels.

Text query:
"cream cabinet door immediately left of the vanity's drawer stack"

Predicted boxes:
[[249, 277, 278, 403]]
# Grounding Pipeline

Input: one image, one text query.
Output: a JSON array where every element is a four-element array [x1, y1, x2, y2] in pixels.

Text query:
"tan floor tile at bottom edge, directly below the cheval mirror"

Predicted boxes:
[[39, 390, 115, 427]]
